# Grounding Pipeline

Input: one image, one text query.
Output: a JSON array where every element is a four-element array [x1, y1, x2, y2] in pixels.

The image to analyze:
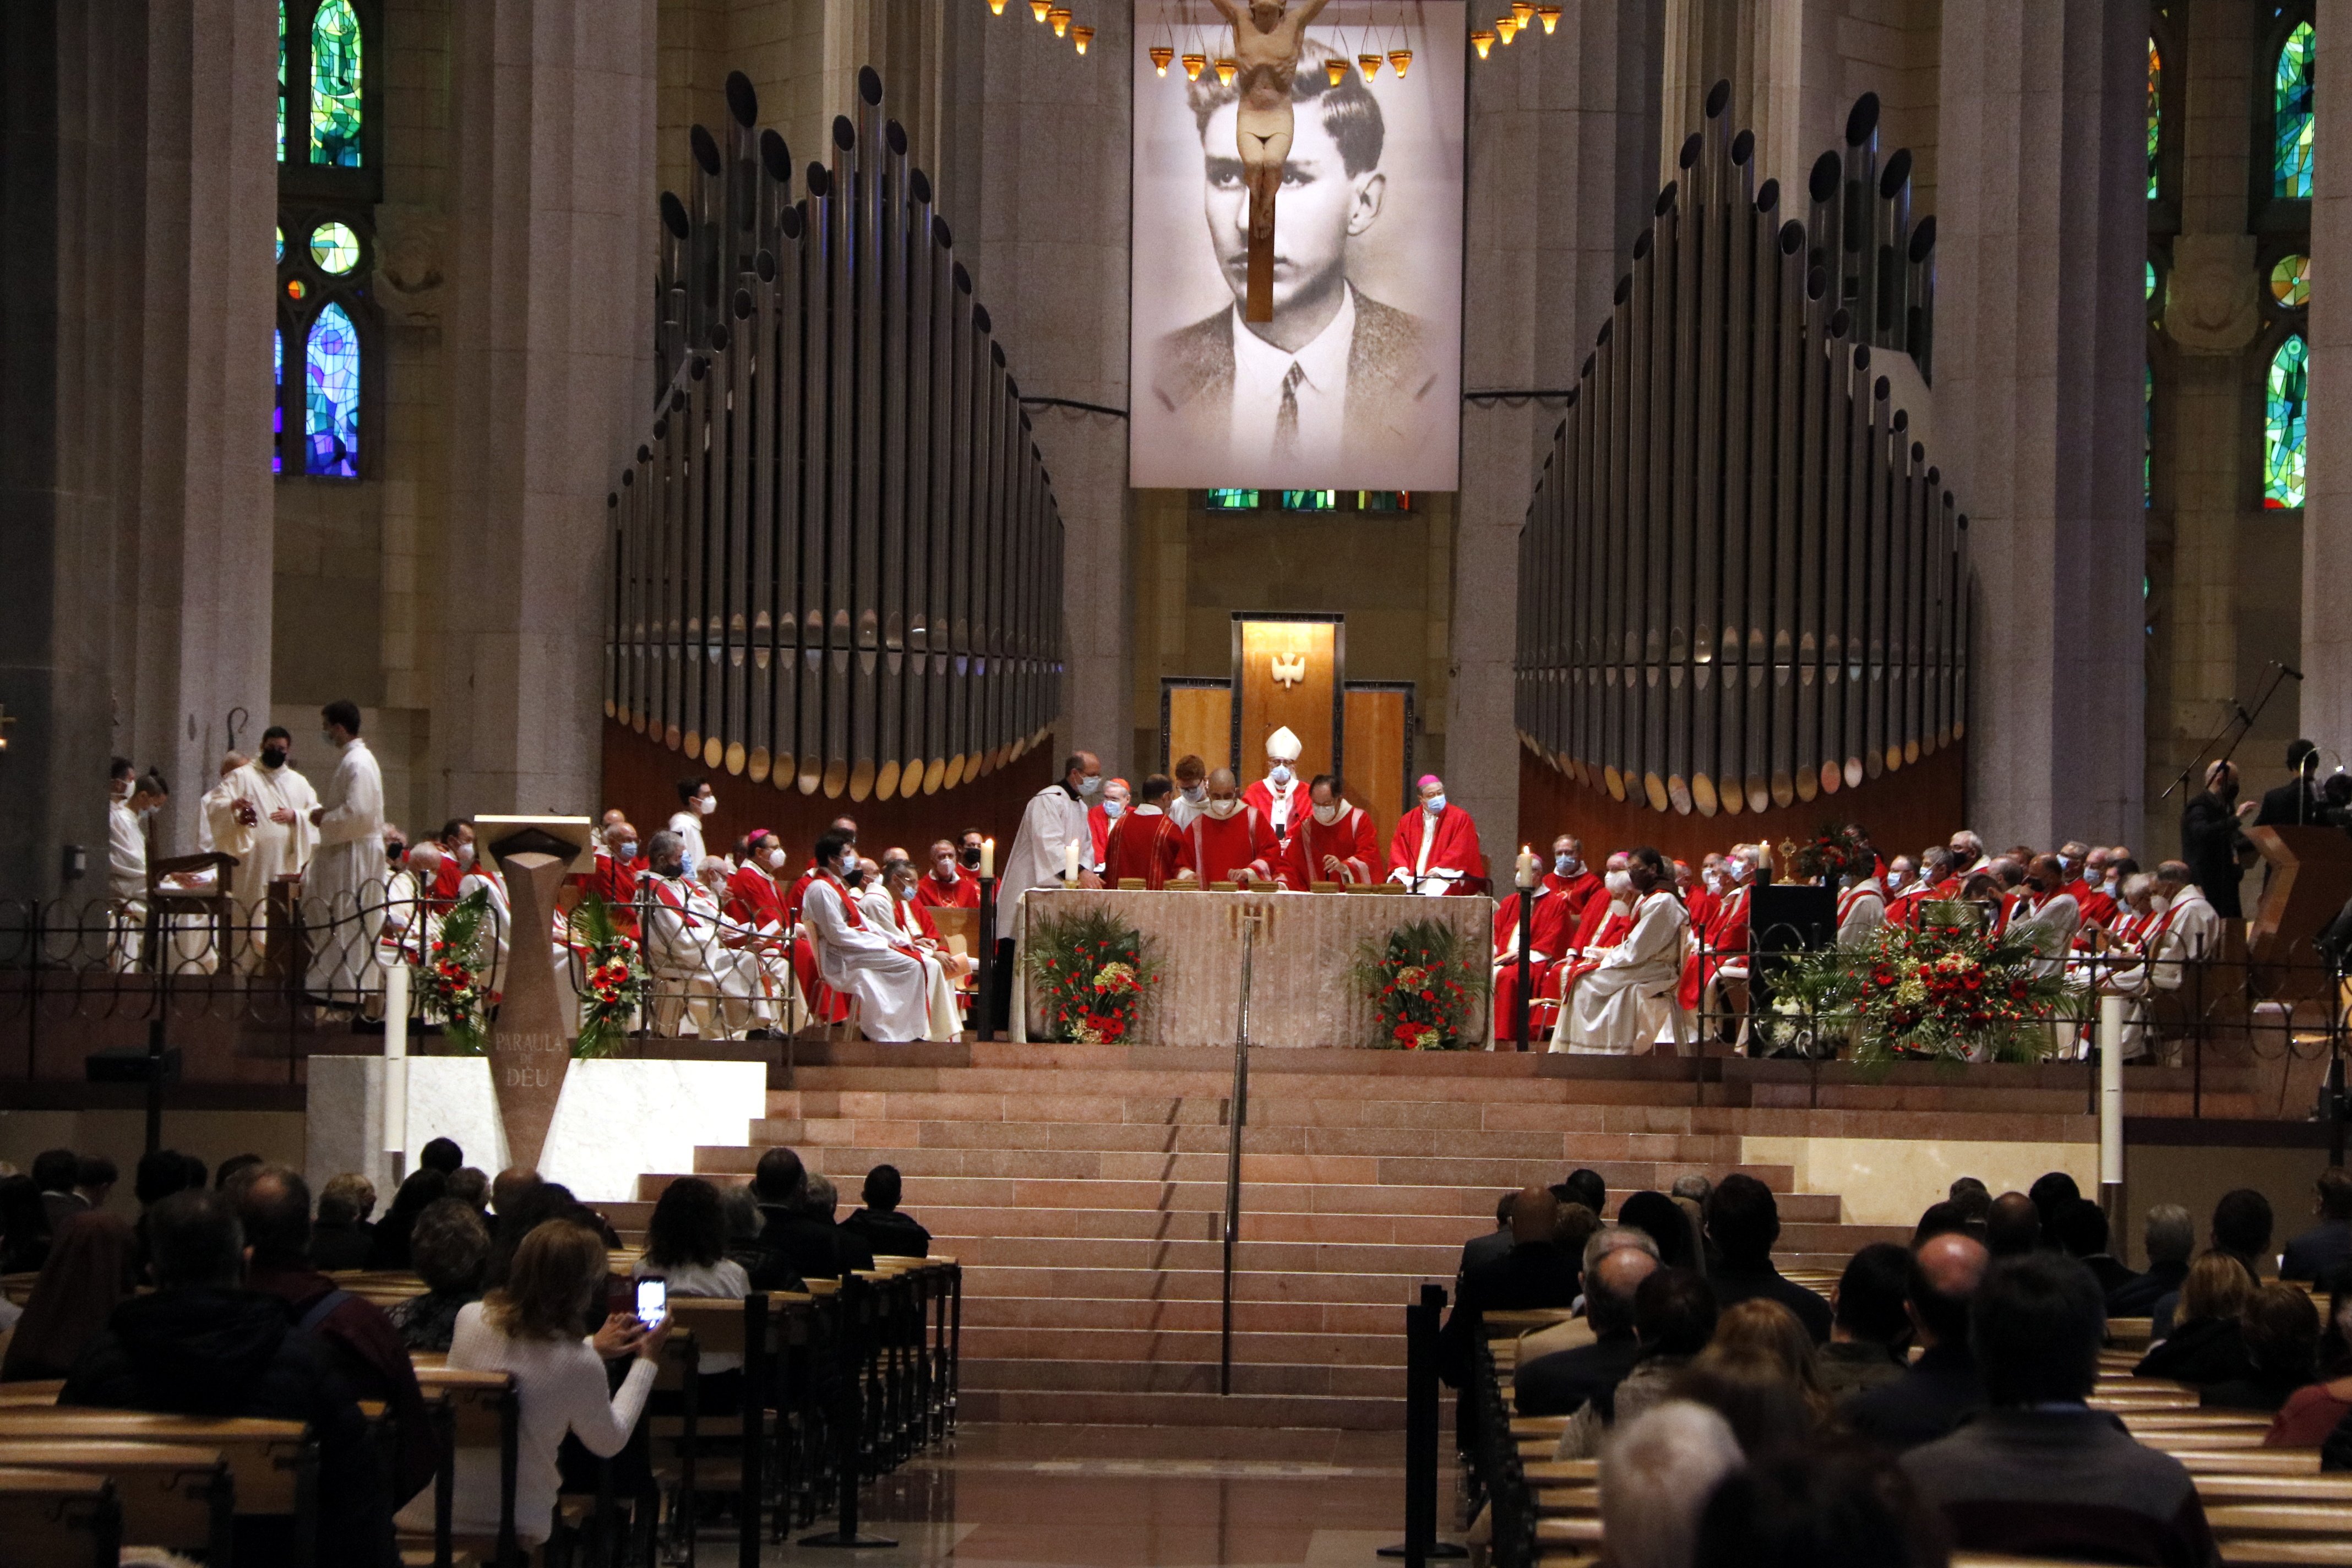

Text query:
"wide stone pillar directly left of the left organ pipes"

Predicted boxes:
[[433, 0, 656, 816]]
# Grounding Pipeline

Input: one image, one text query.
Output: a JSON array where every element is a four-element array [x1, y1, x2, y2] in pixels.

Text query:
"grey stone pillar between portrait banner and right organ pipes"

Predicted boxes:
[[1444, 2, 1660, 870]]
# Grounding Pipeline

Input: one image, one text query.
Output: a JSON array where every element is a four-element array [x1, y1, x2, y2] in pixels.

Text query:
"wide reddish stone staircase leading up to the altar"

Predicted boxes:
[[609, 1044, 1947, 1429]]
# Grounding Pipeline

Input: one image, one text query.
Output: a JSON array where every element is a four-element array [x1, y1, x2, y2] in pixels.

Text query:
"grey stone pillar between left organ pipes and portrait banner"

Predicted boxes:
[[934, 5, 1139, 776]]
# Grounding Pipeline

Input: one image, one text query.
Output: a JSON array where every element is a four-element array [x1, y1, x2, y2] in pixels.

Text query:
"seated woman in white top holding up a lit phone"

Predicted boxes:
[[400, 1220, 671, 1547]]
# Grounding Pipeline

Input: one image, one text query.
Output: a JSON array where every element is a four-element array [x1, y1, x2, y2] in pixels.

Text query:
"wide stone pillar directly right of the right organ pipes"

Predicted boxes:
[[1936, 0, 2147, 844]]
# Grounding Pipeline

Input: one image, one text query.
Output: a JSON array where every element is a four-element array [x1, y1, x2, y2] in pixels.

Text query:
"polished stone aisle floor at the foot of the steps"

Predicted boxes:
[[757, 1425, 1453, 1568]]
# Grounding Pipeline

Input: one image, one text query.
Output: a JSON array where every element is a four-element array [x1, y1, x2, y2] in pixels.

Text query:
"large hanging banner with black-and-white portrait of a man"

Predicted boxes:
[[1129, 0, 1465, 489]]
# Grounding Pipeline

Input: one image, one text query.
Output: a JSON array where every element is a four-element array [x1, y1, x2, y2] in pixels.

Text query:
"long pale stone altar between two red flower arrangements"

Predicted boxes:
[[1014, 889, 1494, 1046]]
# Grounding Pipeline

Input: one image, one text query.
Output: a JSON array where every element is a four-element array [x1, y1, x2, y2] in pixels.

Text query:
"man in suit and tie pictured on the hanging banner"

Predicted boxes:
[[1150, 70, 1453, 484]]
